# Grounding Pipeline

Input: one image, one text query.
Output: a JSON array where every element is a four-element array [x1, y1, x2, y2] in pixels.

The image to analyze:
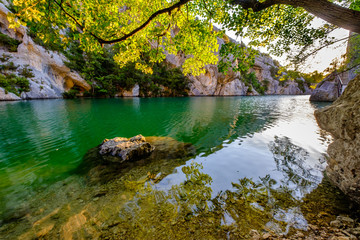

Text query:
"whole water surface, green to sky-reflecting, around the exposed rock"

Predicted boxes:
[[0, 96, 356, 239]]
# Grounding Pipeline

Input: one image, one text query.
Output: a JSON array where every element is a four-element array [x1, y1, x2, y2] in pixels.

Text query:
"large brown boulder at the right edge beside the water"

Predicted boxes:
[[315, 75, 360, 203]]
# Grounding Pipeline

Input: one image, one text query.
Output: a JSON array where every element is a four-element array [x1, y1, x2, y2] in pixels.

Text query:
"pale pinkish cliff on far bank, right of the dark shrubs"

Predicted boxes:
[[165, 35, 311, 96]]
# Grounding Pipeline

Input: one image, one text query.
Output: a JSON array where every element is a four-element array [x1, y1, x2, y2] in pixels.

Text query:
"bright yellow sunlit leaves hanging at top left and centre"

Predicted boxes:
[[12, 0, 228, 75]]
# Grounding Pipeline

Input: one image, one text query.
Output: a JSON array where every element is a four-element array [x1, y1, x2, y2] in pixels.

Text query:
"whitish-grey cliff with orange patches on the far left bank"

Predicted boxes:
[[0, 3, 91, 100]]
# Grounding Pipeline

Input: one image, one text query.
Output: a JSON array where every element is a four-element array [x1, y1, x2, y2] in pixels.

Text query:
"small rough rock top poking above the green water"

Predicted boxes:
[[99, 135, 154, 162]]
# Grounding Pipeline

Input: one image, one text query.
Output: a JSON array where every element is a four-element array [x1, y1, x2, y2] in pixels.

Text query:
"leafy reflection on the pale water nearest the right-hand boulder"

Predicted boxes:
[[269, 136, 321, 194]]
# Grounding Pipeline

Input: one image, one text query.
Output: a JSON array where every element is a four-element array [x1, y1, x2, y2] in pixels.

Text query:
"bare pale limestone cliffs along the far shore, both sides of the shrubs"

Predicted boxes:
[[0, 3, 311, 100]]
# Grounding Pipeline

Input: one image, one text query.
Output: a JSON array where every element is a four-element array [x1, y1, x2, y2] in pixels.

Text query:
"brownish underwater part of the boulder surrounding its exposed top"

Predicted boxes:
[[74, 136, 196, 184]]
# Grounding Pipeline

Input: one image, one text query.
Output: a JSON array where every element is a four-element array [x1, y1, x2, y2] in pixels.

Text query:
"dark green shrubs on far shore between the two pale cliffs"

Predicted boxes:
[[65, 42, 188, 97]]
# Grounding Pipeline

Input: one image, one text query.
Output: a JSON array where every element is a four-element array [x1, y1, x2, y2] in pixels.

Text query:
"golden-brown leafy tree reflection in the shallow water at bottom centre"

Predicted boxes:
[[106, 163, 297, 239]]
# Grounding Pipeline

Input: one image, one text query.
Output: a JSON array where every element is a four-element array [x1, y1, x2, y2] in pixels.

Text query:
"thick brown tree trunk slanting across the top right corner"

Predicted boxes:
[[232, 0, 360, 33]]
